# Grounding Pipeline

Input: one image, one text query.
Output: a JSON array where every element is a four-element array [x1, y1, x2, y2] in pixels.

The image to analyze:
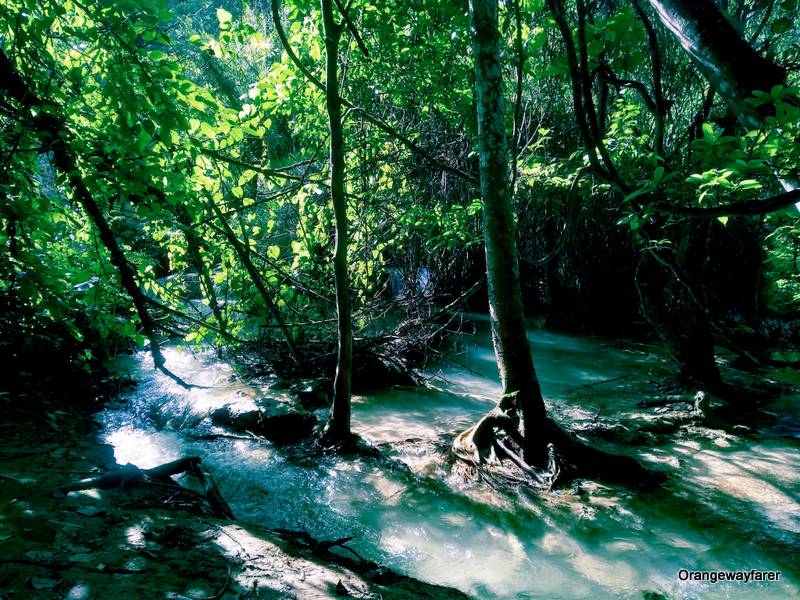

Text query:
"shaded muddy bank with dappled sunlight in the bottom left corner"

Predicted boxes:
[[0, 413, 466, 600]]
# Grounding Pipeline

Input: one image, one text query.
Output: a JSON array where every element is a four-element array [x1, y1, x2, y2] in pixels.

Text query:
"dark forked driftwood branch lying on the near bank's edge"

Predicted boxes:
[[58, 456, 234, 519]]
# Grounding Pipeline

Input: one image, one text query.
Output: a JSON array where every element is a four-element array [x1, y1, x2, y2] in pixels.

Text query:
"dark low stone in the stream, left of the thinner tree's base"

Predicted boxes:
[[210, 398, 317, 444]]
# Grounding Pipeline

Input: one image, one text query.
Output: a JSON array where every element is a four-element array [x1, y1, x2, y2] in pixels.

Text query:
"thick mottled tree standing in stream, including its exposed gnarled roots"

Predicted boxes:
[[453, 0, 650, 485]]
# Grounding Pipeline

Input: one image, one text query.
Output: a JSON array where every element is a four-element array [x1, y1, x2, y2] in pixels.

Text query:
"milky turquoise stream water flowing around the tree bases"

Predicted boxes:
[[100, 320, 800, 599]]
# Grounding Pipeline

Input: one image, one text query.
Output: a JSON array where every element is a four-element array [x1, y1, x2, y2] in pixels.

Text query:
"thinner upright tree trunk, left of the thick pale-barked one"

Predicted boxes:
[[321, 0, 353, 440]]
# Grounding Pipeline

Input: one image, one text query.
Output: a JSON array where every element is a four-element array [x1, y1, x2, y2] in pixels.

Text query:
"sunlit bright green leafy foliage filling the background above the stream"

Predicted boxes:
[[0, 0, 800, 360]]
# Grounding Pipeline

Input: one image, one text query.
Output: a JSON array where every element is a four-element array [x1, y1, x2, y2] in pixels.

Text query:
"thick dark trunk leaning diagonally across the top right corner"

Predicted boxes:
[[649, 0, 786, 127]]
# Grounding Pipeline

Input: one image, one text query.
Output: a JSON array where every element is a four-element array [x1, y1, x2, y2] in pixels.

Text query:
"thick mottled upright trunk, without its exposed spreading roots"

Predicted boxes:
[[470, 0, 546, 464]]
